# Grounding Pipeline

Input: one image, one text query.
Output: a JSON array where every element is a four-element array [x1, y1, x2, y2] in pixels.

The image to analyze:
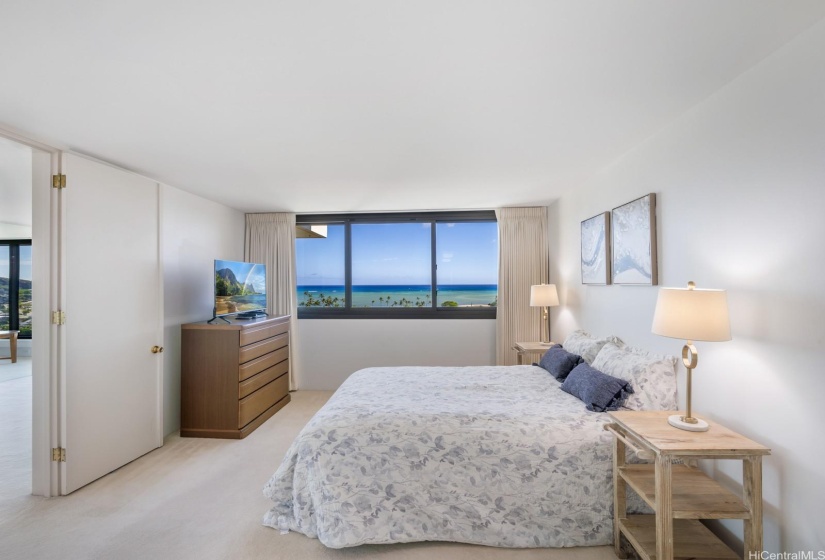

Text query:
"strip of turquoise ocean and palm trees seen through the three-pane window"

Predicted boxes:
[[296, 284, 498, 307]]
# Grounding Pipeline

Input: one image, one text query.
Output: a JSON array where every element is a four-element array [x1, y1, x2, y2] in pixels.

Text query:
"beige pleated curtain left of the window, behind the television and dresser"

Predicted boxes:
[[244, 212, 298, 390]]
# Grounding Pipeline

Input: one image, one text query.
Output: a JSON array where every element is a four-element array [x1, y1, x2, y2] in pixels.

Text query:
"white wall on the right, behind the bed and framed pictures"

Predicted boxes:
[[550, 23, 825, 552]]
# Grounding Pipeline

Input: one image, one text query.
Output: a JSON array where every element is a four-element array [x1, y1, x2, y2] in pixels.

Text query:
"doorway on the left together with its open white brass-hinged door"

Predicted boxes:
[[0, 130, 163, 498]]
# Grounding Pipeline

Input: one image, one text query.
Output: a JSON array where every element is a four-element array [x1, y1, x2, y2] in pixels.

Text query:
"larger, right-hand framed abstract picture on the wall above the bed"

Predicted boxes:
[[611, 193, 659, 286]]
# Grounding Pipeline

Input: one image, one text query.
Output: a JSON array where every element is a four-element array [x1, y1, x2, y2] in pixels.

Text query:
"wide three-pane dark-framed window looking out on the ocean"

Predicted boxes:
[[296, 211, 498, 319]]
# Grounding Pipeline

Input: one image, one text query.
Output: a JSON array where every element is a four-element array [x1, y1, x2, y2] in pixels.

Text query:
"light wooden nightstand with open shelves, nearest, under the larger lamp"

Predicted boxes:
[[607, 411, 771, 560]]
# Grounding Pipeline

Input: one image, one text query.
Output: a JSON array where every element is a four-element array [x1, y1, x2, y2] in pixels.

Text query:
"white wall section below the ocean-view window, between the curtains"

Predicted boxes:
[[296, 319, 496, 390]]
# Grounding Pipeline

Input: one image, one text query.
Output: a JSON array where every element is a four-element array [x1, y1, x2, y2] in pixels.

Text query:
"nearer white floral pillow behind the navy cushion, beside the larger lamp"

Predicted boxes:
[[593, 343, 676, 410]]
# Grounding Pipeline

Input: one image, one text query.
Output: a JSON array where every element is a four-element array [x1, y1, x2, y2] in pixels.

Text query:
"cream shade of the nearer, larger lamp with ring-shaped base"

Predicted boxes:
[[652, 288, 730, 342]]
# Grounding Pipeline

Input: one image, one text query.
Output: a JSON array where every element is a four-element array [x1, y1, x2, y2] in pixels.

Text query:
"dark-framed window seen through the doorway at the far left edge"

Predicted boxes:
[[0, 240, 32, 338]]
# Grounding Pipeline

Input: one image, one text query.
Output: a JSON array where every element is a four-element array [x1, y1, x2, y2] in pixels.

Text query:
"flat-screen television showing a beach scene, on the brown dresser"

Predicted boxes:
[[215, 260, 266, 317]]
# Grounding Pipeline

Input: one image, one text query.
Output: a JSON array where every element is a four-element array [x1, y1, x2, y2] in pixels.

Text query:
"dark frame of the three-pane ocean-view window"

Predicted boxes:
[[295, 210, 497, 319]]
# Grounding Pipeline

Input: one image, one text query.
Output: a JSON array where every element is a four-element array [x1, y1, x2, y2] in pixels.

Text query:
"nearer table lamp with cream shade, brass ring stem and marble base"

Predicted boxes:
[[652, 282, 730, 432]]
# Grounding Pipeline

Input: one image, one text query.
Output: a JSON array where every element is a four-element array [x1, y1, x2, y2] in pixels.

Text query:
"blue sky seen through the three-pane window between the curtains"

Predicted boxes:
[[296, 222, 498, 286]]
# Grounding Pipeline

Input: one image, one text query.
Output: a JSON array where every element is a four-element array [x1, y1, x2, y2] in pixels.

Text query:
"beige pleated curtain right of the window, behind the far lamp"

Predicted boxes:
[[496, 207, 550, 366]]
